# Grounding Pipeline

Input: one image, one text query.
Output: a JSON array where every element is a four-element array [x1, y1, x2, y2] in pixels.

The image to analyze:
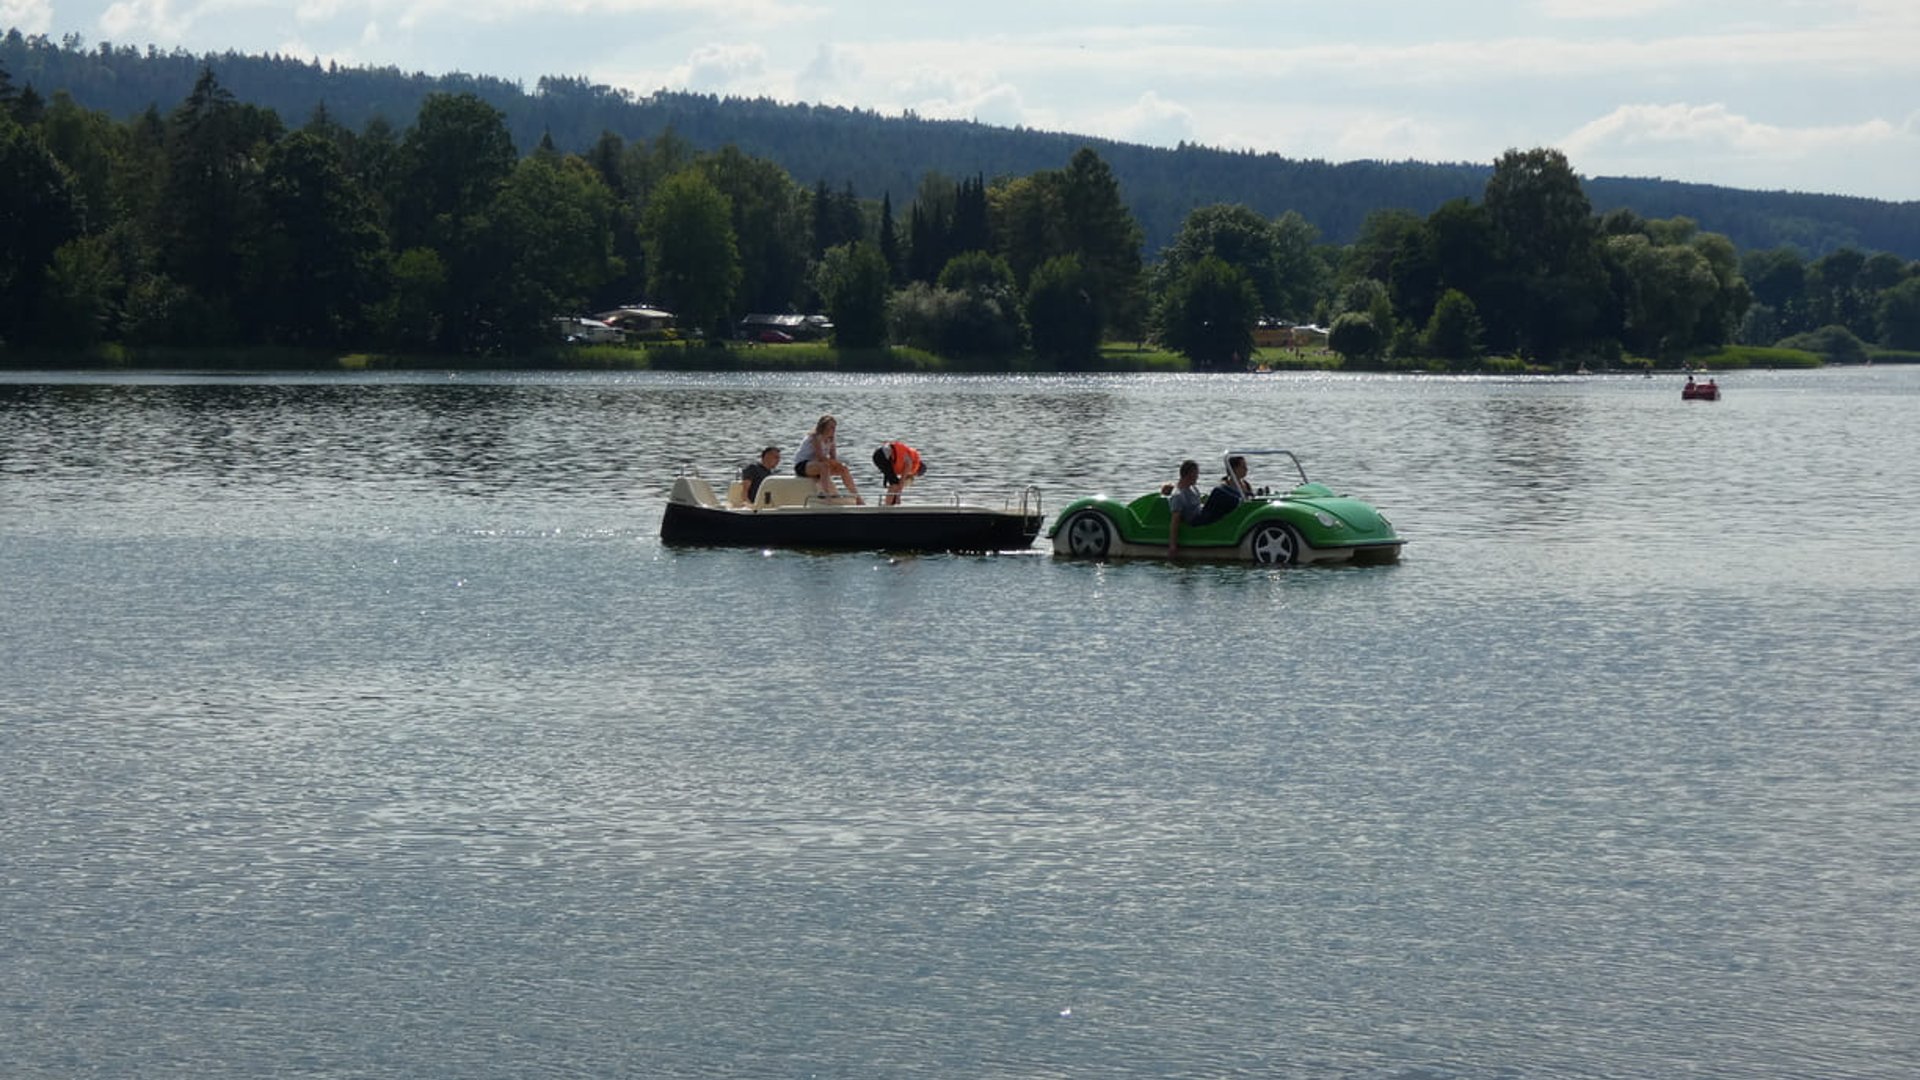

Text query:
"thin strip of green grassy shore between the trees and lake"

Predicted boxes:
[[0, 342, 1889, 375]]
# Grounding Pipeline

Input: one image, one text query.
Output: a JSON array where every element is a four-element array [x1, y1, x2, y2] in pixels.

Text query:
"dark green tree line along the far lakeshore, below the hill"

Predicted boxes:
[[0, 67, 1920, 369]]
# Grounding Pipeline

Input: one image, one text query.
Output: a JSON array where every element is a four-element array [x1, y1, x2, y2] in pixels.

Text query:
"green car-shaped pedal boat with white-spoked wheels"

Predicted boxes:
[[1046, 450, 1405, 567]]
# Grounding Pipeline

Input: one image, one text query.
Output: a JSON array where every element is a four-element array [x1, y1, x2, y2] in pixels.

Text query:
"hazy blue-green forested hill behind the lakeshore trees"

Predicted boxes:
[[0, 31, 1920, 259]]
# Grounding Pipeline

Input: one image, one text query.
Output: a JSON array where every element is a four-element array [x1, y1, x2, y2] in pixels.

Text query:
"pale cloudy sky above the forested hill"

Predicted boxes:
[[0, 0, 1920, 202]]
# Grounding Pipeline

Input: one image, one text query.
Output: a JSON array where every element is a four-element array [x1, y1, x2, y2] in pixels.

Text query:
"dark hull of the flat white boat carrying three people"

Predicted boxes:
[[660, 502, 1043, 552]]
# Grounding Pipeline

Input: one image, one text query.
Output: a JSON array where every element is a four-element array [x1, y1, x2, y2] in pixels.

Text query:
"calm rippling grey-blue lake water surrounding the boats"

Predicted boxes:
[[0, 367, 1920, 1080]]
